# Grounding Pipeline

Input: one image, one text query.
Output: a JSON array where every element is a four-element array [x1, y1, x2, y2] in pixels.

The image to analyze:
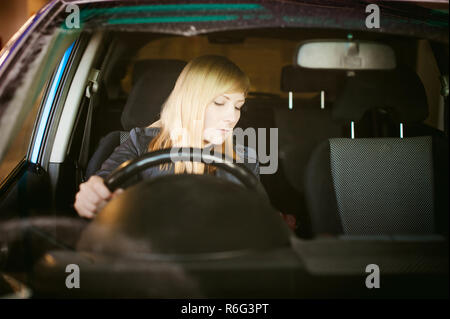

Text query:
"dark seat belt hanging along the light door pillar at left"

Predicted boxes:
[[78, 69, 100, 182]]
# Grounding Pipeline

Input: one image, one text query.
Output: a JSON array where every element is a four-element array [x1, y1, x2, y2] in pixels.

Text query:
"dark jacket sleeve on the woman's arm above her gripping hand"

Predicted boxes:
[[95, 129, 139, 179]]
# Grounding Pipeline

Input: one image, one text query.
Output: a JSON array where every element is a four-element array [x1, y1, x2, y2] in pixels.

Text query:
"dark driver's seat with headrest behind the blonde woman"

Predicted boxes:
[[85, 59, 186, 180]]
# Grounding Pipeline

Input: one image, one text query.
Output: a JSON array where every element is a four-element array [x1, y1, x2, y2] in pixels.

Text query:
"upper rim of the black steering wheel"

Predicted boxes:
[[105, 147, 268, 199]]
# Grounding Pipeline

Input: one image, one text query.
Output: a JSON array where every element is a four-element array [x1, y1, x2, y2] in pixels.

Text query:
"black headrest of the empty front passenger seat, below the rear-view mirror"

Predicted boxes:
[[333, 66, 428, 123]]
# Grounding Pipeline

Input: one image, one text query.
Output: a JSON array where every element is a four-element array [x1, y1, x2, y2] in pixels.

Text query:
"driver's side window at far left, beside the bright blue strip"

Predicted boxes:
[[0, 12, 78, 182]]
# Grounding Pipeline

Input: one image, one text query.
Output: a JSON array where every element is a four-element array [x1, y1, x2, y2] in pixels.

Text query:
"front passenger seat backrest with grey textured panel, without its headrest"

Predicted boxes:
[[306, 137, 436, 235]]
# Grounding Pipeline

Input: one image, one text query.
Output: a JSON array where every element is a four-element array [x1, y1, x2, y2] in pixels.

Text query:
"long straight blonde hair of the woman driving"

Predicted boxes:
[[148, 55, 250, 174]]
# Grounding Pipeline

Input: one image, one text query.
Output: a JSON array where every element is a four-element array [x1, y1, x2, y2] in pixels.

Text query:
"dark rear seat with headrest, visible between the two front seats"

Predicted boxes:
[[271, 65, 349, 238]]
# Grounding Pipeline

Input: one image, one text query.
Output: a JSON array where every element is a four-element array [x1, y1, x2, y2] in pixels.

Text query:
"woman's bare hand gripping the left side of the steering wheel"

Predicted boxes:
[[74, 175, 123, 218]]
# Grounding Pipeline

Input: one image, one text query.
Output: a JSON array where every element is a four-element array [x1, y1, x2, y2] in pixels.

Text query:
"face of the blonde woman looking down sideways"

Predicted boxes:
[[203, 93, 245, 145]]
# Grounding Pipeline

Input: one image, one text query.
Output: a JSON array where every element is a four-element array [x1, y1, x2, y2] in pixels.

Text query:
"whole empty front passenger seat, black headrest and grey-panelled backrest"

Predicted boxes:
[[304, 67, 448, 235]]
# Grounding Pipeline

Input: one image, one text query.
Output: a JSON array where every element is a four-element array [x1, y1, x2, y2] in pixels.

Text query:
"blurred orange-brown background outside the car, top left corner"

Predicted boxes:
[[0, 0, 49, 47]]
